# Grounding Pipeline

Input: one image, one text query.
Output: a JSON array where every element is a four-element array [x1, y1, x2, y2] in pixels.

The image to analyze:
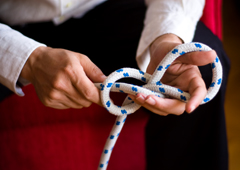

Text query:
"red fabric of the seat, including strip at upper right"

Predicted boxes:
[[0, 0, 221, 170]]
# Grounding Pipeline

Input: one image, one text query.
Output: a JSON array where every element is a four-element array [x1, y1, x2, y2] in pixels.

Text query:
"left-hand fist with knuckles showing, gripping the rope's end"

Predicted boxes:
[[20, 47, 106, 109]]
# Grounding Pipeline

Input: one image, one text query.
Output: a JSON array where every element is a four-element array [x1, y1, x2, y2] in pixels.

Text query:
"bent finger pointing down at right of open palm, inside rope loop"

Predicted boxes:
[[186, 77, 207, 113]]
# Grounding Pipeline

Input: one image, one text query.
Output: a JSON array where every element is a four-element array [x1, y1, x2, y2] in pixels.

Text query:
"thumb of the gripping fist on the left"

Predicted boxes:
[[80, 56, 106, 83]]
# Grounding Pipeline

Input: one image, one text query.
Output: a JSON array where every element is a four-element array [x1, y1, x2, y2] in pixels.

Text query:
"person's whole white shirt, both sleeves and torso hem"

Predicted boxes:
[[0, 0, 205, 96]]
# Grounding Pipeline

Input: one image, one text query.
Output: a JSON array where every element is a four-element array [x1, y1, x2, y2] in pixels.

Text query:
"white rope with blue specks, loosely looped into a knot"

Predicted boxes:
[[95, 43, 222, 170]]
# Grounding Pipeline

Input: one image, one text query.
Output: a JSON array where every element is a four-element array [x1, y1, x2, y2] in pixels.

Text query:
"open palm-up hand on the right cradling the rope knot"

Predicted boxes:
[[129, 34, 217, 116]]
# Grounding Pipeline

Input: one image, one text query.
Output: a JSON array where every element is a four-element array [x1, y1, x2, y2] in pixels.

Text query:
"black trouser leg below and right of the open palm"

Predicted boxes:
[[146, 22, 230, 170]]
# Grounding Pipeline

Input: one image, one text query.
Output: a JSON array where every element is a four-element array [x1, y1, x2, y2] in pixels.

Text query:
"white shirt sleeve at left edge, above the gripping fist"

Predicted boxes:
[[0, 23, 45, 96]]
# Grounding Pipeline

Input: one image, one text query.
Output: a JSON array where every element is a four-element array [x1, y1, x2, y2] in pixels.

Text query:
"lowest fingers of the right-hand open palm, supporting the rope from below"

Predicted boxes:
[[130, 93, 186, 115]]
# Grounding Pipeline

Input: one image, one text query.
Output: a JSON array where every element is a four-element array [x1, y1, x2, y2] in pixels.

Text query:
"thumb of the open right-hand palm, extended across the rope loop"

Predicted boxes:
[[176, 50, 217, 66]]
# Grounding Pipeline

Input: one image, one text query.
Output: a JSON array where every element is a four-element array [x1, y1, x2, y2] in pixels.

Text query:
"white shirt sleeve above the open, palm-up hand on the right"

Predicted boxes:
[[136, 0, 205, 71]]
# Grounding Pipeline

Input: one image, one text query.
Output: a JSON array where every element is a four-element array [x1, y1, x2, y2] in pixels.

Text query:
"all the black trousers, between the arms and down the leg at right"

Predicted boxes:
[[7, 0, 229, 170]]
